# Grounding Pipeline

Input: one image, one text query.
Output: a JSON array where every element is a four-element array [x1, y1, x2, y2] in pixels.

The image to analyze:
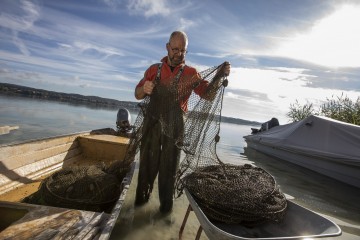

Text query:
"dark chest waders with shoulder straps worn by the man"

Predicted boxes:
[[135, 64, 184, 213]]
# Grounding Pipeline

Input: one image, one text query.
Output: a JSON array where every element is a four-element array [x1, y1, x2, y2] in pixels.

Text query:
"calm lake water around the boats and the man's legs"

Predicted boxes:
[[0, 95, 360, 240]]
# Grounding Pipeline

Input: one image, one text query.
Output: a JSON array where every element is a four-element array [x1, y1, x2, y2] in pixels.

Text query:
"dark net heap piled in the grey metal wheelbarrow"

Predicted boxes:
[[182, 164, 286, 226]]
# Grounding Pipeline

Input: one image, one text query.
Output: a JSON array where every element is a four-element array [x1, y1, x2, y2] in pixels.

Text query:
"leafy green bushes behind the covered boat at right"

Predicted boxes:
[[286, 94, 360, 125]]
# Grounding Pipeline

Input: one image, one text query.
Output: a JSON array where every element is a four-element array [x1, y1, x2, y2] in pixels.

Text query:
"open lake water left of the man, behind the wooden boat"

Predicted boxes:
[[0, 95, 137, 144]]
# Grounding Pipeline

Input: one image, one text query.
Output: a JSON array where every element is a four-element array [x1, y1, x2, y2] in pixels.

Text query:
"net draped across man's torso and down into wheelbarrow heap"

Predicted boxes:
[[124, 61, 287, 225]]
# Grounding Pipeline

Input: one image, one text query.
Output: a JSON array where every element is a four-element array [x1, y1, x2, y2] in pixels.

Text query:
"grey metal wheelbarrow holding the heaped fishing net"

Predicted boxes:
[[179, 189, 342, 240]]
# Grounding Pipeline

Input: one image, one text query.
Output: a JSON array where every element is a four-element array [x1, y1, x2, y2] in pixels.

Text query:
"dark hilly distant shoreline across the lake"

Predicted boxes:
[[0, 83, 261, 126]]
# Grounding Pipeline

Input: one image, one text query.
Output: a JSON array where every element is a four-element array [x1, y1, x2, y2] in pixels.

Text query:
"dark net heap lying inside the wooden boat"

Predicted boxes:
[[23, 161, 129, 212]]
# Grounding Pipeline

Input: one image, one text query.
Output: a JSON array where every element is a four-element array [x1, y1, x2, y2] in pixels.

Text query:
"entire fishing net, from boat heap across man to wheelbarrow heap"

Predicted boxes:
[[25, 64, 286, 225]]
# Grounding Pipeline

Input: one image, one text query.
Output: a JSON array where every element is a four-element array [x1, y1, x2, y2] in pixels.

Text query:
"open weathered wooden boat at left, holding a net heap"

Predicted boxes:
[[0, 128, 135, 240]]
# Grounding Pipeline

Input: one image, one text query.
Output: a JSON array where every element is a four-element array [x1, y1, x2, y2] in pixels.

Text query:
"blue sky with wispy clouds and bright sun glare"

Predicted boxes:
[[0, 0, 360, 124]]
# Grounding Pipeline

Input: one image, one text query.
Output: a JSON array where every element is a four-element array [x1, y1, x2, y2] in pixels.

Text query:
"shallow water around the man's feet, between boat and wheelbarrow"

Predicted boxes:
[[110, 171, 208, 240]]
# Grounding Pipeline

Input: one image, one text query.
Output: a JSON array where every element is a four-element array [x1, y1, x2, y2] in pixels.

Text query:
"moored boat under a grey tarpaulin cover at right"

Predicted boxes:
[[244, 115, 360, 188]]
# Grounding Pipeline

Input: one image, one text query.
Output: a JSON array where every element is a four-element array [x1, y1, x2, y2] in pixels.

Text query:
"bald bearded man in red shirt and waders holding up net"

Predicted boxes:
[[135, 31, 230, 213]]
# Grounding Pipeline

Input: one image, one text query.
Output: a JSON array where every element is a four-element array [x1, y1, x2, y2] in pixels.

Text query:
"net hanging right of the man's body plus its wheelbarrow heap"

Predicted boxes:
[[169, 65, 287, 225]]
